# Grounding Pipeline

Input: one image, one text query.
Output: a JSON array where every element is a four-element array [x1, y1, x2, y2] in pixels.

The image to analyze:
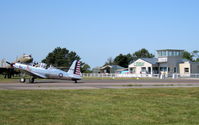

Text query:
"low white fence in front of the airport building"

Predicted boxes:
[[82, 73, 199, 79]]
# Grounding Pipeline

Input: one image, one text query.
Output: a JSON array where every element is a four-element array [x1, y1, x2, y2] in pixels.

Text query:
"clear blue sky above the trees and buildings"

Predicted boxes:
[[0, 0, 199, 68]]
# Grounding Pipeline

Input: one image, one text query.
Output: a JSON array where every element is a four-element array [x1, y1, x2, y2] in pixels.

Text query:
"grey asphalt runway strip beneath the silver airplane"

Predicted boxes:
[[0, 79, 199, 90]]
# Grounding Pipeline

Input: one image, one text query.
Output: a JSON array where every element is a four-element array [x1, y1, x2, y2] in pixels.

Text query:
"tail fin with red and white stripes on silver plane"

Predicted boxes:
[[68, 60, 81, 76]]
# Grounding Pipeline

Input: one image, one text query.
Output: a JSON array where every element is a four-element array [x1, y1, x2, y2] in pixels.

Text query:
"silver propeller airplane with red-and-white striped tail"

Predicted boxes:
[[7, 61, 82, 83]]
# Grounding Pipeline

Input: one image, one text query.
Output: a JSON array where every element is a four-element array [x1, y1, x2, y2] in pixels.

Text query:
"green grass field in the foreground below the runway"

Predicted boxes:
[[0, 88, 199, 125]]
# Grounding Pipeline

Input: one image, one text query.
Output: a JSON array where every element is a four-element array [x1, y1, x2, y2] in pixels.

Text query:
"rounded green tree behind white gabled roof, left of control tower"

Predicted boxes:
[[133, 48, 154, 60]]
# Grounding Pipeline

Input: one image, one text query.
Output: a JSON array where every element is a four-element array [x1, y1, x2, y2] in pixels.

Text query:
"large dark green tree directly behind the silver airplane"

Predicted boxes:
[[42, 47, 80, 67]]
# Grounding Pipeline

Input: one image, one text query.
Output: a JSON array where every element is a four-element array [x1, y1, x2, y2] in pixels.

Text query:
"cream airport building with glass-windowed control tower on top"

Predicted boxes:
[[128, 49, 199, 76]]
